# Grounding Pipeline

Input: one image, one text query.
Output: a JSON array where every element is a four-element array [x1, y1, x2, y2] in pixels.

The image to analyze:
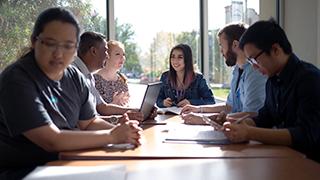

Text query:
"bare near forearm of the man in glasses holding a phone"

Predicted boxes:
[[248, 126, 292, 146]]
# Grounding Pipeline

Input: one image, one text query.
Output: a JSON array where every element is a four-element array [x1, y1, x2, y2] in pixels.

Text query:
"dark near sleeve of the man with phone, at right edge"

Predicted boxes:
[[288, 71, 320, 155]]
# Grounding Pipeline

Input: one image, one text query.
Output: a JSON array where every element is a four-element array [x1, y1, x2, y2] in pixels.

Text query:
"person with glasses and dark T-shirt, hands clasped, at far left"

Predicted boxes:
[[0, 8, 141, 179]]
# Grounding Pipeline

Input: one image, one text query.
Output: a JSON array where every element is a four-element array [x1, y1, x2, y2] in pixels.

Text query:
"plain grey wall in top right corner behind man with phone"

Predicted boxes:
[[283, 0, 320, 67]]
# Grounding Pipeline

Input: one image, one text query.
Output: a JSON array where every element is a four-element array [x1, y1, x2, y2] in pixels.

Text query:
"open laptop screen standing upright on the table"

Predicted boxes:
[[140, 81, 162, 121]]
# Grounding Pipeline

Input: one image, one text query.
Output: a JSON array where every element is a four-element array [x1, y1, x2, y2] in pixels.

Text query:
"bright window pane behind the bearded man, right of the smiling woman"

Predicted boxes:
[[208, 0, 259, 98]]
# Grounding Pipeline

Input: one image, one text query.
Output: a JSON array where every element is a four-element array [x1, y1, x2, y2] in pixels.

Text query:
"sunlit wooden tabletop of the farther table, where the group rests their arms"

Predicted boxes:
[[60, 115, 304, 160]]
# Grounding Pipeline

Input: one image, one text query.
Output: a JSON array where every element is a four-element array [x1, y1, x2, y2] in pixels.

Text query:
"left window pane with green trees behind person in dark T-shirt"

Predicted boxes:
[[0, 0, 106, 72]]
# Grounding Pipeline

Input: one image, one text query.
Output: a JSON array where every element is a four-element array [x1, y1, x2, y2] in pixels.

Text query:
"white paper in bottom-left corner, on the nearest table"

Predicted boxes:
[[24, 165, 126, 180]]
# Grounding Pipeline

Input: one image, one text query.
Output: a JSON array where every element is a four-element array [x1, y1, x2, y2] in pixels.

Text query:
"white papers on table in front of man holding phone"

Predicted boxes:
[[165, 124, 230, 144]]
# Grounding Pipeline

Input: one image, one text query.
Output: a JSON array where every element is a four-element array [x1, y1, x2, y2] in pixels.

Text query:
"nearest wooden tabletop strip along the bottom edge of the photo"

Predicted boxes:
[[48, 158, 320, 180]]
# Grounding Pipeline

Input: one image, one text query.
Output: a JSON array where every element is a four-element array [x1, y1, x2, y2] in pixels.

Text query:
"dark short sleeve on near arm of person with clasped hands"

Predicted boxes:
[[0, 68, 51, 136]]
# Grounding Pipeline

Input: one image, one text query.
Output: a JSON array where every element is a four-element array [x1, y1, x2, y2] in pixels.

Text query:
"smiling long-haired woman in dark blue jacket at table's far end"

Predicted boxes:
[[157, 44, 215, 107]]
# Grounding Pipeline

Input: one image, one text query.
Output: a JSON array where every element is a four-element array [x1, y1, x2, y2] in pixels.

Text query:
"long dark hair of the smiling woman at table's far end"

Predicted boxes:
[[169, 44, 195, 88]]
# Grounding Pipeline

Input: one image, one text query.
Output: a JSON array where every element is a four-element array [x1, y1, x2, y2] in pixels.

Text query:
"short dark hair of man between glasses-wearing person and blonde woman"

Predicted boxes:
[[78, 31, 106, 56]]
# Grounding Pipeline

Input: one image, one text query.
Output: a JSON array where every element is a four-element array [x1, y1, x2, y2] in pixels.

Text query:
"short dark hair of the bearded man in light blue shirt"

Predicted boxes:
[[218, 23, 247, 47]]
